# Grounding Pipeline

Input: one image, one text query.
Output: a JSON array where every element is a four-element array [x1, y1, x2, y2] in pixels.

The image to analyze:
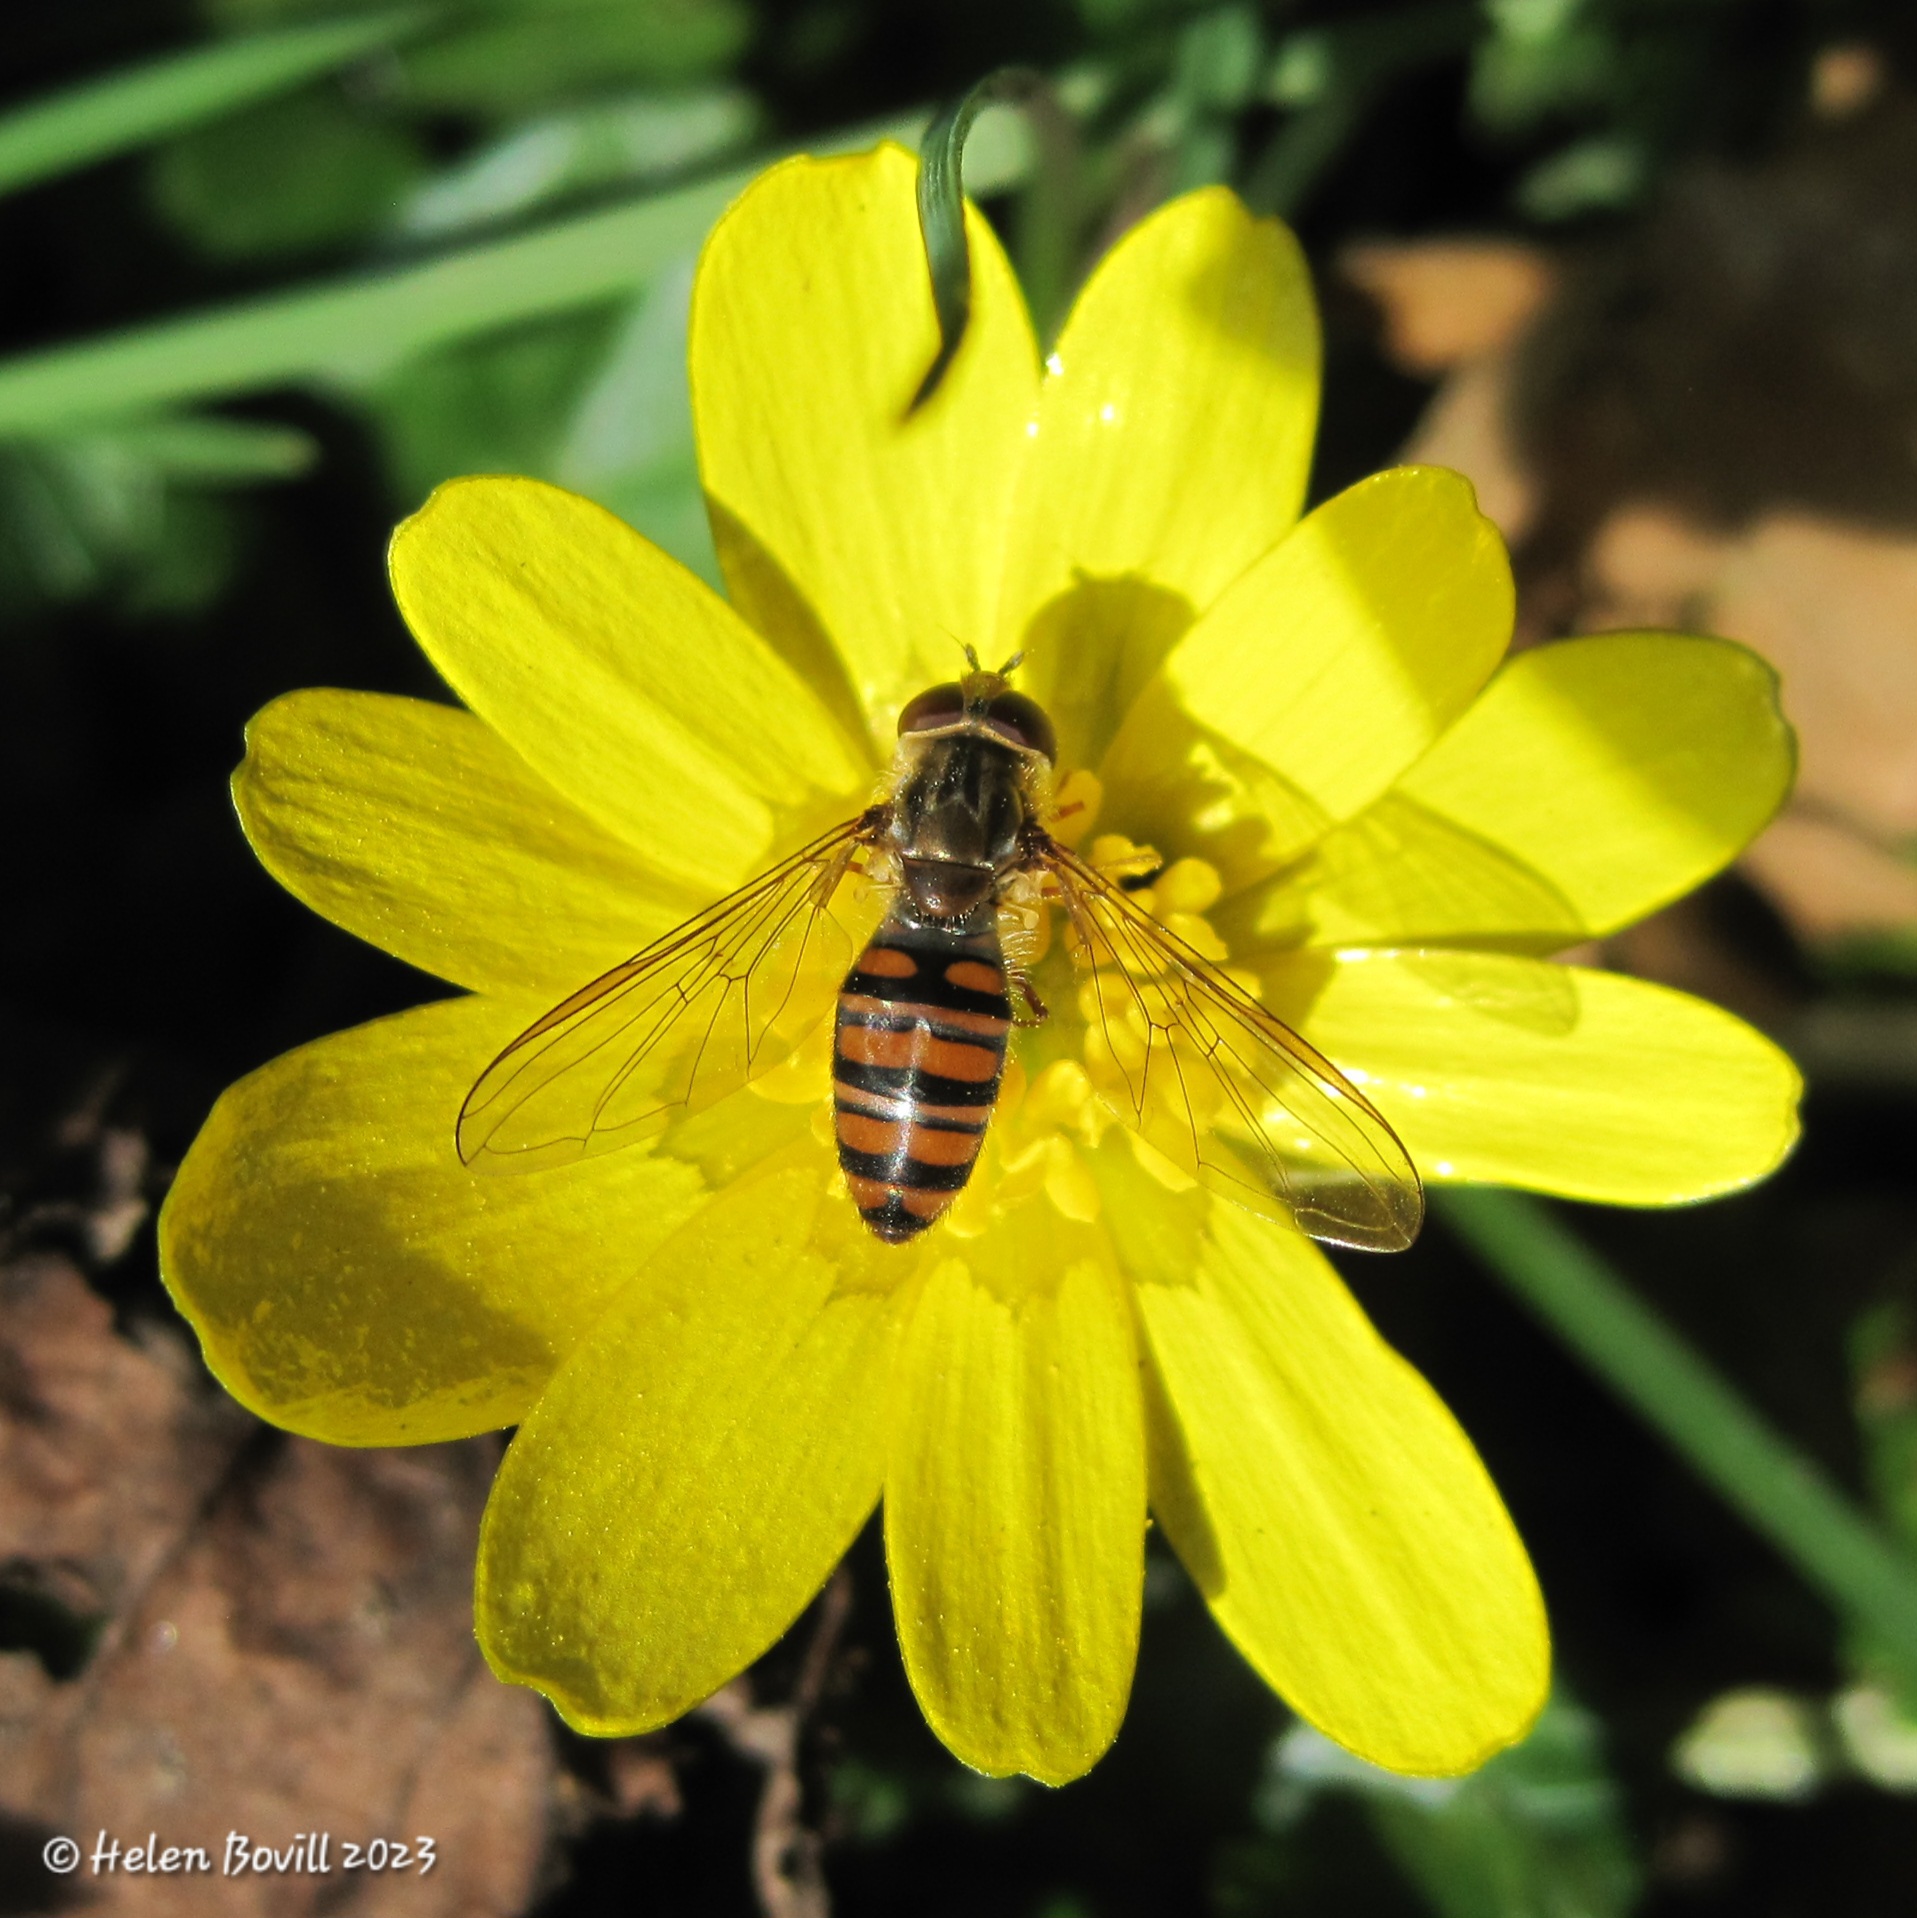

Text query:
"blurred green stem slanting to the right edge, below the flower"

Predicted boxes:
[[1433, 1189, 1917, 1676]]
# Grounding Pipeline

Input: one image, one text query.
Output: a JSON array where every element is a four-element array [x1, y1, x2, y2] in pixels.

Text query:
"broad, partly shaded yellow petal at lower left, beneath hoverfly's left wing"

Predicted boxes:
[[159, 999, 702, 1444]]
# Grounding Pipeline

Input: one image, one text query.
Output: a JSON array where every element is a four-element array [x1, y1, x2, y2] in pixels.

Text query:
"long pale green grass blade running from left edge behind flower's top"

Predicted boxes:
[[0, 119, 919, 435]]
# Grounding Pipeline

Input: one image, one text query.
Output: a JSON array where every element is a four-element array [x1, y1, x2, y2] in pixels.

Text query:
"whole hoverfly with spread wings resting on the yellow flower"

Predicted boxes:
[[459, 648, 1424, 1251]]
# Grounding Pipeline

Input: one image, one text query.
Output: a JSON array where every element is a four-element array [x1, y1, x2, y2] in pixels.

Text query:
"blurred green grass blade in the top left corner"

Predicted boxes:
[[0, 8, 432, 194]]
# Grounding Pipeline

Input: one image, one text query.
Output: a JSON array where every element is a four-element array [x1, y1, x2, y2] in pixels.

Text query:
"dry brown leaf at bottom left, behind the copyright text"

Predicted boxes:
[[0, 1258, 555, 1918]]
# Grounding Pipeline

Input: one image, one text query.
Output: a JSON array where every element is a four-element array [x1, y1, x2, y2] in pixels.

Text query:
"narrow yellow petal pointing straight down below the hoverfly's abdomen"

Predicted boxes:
[[885, 1199, 1146, 1784]]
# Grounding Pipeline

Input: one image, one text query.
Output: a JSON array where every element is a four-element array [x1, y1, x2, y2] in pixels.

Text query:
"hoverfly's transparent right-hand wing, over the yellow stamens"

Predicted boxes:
[[1042, 844, 1424, 1252]]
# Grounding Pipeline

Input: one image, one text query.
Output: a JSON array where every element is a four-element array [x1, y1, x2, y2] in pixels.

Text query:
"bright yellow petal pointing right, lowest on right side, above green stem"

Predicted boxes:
[[1265, 951, 1802, 1205]]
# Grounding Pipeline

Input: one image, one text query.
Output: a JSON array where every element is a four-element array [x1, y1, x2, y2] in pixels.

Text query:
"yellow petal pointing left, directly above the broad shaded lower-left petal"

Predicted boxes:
[[232, 689, 702, 1001]]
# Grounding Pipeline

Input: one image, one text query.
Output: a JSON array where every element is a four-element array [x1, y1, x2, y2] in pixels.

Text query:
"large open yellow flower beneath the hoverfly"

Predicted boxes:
[[163, 150, 1798, 1780]]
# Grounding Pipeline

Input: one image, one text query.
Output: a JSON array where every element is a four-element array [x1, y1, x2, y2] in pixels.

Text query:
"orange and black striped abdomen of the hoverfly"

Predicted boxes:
[[833, 915, 1011, 1245]]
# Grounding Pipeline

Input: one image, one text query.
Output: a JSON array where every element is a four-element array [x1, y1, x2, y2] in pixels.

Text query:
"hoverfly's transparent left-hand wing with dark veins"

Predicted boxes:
[[459, 815, 869, 1172]]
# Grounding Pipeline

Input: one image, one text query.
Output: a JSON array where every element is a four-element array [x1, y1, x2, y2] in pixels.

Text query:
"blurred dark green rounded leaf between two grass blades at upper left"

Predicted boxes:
[[150, 90, 426, 259]]
